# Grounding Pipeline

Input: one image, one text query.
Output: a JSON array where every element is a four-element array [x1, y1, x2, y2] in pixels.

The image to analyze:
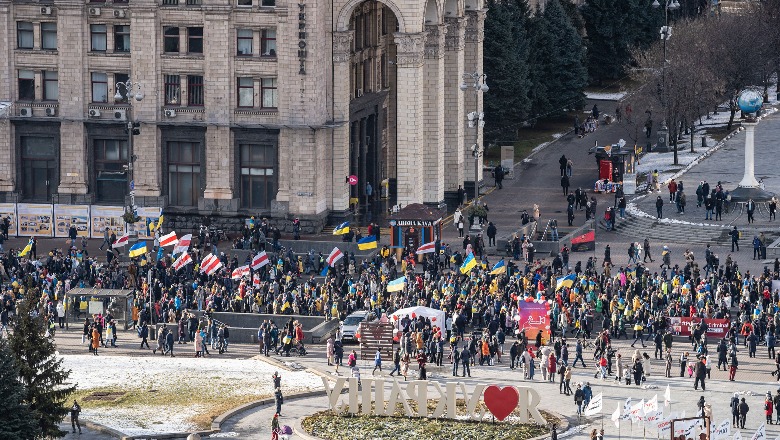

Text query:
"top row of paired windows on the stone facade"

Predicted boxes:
[[16, 21, 276, 57]]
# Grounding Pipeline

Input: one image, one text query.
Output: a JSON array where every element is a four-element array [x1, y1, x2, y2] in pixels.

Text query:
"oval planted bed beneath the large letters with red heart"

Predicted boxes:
[[301, 399, 559, 440]]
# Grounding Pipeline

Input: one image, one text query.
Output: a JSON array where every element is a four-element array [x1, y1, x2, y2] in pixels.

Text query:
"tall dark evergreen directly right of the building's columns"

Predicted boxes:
[[483, 0, 530, 140]]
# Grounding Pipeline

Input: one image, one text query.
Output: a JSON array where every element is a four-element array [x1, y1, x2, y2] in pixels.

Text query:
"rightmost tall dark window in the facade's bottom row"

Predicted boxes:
[[238, 144, 276, 208]]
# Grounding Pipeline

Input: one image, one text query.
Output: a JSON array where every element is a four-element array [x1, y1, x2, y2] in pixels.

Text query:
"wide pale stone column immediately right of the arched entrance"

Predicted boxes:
[[395, 32, 428, 207]]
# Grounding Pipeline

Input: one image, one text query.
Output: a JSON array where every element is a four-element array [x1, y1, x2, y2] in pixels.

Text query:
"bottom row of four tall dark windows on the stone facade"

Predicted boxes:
[[20, 136, 278, 209]]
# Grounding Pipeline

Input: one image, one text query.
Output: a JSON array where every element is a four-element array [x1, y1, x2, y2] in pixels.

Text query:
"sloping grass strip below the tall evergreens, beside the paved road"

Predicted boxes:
[[485, 113, 582, 166]]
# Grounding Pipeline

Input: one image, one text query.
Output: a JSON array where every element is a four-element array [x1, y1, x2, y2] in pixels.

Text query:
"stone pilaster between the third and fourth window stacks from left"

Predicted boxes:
[[198, 7, 238, 211]]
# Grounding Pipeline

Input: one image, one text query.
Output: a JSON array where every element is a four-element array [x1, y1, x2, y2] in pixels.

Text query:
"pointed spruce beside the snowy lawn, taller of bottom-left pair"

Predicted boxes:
[[8, 289, 76, 437]]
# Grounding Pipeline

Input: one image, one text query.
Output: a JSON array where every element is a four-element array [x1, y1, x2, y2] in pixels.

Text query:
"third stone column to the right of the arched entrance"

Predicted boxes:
[[443, 17, 466, 206]]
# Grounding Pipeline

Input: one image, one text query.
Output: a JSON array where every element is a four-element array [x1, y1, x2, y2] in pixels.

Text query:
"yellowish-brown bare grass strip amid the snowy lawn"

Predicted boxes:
[[67, 385, 270, 429]]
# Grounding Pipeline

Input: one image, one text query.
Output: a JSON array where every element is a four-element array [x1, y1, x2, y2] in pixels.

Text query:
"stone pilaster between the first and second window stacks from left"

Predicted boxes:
[[55, 5, 90, 199]]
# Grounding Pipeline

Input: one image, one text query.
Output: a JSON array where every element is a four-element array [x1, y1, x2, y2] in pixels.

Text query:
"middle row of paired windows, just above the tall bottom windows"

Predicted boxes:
[[18, 70, 279, 109]]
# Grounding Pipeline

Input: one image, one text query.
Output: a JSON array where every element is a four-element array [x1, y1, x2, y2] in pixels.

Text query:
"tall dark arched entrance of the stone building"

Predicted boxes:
[[349, 0, 398, 214]]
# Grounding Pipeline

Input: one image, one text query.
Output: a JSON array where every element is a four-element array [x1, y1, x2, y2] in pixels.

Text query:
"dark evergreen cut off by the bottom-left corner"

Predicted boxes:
[[0, 341, 40, 440]]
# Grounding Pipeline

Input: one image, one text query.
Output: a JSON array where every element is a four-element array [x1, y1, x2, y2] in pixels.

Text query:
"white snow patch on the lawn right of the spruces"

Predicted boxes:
[[62, 355, 322, 435]]
